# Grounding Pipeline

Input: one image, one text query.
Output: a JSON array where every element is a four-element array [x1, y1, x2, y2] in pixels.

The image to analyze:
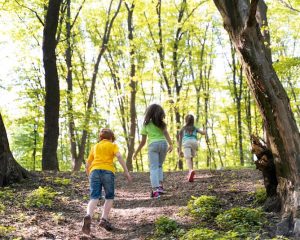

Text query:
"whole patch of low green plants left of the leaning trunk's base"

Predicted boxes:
[[150, 193, 286, 240]]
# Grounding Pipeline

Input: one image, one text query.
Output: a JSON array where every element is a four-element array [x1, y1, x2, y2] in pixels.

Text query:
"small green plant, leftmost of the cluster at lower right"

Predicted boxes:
[[155, 216, 178, 236]]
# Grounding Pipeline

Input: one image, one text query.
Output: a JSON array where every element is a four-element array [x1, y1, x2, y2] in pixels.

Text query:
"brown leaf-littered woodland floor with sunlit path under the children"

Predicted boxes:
[[0, 169, 290, 240]]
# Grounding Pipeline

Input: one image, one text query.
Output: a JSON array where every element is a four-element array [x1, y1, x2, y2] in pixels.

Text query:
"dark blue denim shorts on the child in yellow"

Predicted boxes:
[[90, 169, 115, 200]]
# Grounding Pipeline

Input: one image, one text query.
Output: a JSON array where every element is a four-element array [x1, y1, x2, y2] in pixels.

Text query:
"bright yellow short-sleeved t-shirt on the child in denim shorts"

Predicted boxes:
[[87, 139, 119, 173]]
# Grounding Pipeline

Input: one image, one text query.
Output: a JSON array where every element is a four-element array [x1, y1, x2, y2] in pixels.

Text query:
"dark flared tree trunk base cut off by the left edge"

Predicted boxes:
[[0, 113, 29, 187]]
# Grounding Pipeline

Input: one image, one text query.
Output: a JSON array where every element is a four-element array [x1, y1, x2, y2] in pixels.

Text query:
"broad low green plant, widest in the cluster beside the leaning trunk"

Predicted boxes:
[[216, 207, 264, 236]]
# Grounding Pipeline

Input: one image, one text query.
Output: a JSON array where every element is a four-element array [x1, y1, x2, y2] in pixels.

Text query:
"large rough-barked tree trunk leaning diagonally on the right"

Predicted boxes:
[[214, 0, 300, 236]]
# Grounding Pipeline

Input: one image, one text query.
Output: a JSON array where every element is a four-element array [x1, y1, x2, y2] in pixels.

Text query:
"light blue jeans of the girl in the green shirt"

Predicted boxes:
[[148, 141, 168, 188]]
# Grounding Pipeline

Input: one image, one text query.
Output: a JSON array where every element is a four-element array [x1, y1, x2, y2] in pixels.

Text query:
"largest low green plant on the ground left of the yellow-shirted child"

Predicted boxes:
[[25, 187, 57, 207]]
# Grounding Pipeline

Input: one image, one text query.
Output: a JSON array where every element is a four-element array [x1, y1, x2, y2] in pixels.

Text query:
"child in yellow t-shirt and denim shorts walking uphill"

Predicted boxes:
[[82, 128, 132, 234]]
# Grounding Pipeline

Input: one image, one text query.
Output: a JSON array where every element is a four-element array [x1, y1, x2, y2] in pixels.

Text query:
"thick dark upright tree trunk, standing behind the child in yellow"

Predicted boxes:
[[42, 0, 61, 170]]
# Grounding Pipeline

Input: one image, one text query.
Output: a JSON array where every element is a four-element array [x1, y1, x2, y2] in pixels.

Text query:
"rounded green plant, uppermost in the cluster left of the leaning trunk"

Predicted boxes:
[[188, 195, 221, 220]]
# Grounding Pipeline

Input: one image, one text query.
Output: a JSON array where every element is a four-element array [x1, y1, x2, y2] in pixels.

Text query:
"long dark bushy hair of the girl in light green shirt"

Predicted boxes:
[[144, 104, 166, 130]]
